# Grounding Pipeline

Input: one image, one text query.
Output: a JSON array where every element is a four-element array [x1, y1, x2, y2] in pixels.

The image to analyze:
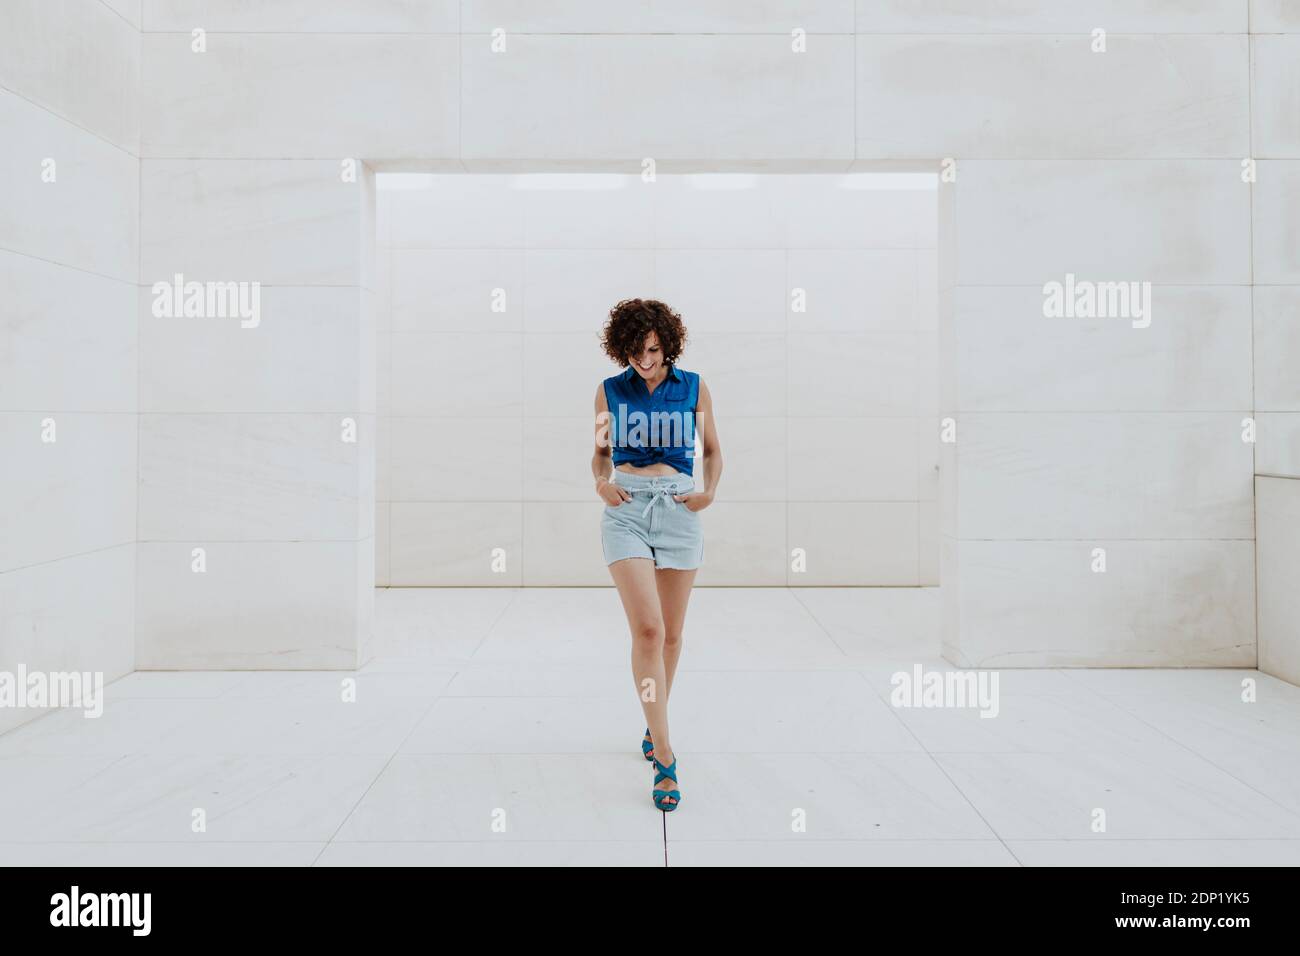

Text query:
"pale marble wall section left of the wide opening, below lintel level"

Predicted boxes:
[[137, 159, 376, 670]]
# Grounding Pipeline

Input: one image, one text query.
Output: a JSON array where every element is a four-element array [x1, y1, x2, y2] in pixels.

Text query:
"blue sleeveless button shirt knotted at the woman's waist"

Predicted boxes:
[[605, 365, 699, 475]]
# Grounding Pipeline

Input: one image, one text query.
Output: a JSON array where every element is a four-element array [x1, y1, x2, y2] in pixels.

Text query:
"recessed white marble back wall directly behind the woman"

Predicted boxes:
[[376, 174, 939, 587]]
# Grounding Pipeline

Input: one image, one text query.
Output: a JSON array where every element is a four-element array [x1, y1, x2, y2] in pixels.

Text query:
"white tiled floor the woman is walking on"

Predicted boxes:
[[0, 588, 1300, 866]]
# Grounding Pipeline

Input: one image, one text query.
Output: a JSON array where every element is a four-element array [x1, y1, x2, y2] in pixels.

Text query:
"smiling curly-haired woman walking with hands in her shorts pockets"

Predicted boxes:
[[592, 299, 723, 813]]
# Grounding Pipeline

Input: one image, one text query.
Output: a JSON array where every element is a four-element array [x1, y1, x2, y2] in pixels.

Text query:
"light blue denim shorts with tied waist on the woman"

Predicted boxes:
[[601, 470, 705, 571]]
